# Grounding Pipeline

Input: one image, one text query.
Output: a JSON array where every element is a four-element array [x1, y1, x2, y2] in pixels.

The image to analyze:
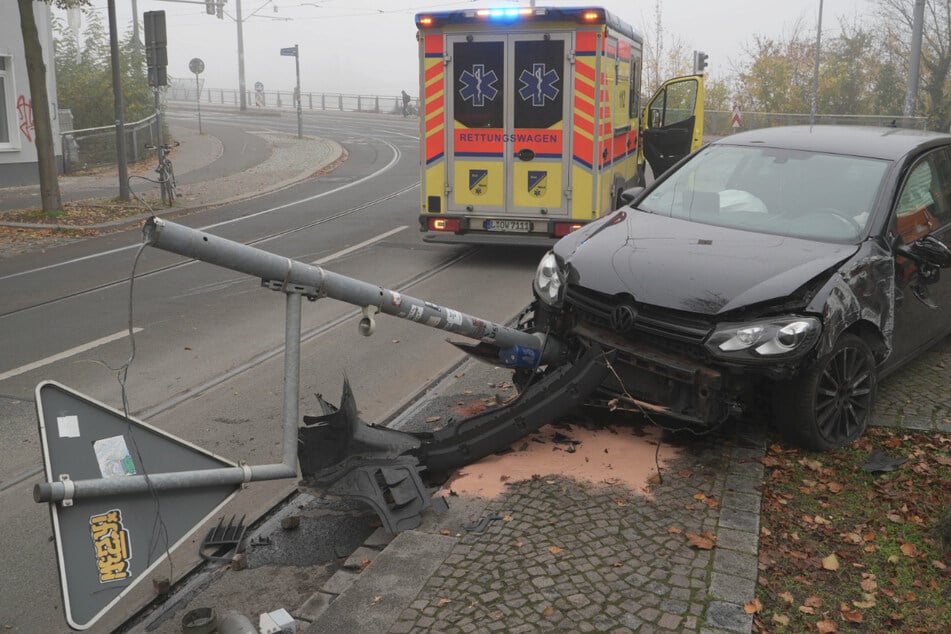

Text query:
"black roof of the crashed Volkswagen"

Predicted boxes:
[[714, 125, 951, 160]]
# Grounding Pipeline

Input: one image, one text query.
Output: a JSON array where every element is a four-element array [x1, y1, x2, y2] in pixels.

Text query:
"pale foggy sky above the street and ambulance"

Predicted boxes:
[[57, 0, 874, 96]]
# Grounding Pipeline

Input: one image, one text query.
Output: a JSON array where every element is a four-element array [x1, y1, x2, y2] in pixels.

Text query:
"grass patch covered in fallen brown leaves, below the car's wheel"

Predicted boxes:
[[744, 428, 951, 633]]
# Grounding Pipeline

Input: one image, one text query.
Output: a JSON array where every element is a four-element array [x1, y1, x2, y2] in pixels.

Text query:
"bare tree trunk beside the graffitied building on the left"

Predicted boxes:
[[17, 0, 88, 215]]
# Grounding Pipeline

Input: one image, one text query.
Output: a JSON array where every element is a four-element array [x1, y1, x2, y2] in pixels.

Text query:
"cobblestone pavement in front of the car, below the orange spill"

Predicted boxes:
[[301, 420, 766, 634]]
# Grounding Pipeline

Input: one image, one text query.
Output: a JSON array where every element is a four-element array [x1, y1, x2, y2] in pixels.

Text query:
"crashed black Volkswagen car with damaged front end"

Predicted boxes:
[[533, 126, 951, 449]]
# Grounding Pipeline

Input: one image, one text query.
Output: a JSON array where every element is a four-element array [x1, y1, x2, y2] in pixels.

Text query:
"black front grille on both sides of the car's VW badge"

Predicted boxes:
[[566, 285, 714, 346]]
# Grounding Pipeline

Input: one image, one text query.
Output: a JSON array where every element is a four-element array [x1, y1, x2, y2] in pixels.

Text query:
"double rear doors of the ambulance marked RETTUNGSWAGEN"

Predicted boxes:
[[446, 32, 571, 232]]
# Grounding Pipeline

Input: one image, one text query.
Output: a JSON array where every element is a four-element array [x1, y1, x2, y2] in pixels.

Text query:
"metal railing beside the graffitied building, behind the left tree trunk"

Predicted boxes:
[[60, 114, 159, 174]]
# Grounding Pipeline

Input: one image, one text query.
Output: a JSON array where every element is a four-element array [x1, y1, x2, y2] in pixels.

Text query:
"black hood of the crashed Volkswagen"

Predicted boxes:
[[554, 209, 858, 315]]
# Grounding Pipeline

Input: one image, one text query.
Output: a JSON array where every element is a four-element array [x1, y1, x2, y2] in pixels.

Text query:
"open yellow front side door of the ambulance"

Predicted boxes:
[[638, 75, 703, 178]]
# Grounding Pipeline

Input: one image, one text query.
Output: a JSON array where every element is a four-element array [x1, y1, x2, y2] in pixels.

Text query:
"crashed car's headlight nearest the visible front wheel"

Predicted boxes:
[[706, 317, 822, 359]]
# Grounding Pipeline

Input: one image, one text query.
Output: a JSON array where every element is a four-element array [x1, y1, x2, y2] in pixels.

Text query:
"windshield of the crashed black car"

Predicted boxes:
[[638, 145, 888, 242]]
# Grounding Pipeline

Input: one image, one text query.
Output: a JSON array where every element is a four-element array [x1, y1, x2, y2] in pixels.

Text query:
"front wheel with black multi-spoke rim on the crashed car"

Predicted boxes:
[[775, 334, 878, 451]]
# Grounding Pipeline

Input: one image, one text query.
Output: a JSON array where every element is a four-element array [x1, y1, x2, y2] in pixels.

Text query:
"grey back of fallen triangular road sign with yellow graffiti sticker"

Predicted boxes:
[[36, 381, 240, 630]]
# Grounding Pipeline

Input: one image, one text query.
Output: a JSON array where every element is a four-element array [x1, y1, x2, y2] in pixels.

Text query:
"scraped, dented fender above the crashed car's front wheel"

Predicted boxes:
[[807, 240, 895, 361]]
